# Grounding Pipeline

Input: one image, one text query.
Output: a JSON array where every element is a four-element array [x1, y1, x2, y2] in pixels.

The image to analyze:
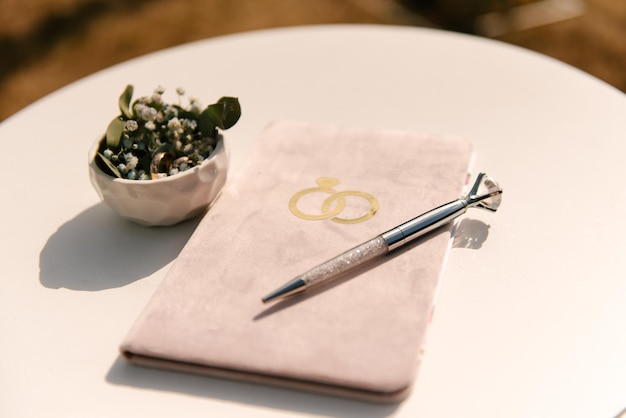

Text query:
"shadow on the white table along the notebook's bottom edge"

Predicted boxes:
[[106, 357, 400, 418]]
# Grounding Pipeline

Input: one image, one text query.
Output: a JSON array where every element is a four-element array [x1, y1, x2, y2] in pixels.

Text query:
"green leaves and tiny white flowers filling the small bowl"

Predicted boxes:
[[95, 85, 241, 180]]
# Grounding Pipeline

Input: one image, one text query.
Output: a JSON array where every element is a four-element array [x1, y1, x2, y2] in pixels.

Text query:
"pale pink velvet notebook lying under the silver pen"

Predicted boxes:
[[121, 122, 472, 402]]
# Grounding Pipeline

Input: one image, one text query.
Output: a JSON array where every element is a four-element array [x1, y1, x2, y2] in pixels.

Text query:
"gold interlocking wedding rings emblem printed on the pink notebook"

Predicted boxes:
[[289, 177, 378, 224]]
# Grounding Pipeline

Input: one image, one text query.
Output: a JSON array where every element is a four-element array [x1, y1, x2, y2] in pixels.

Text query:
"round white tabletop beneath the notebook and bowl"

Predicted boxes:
[[0, 26, 626, 418]]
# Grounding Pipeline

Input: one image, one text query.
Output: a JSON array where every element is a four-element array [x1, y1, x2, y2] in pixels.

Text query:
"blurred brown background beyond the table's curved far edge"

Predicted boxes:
[[0, 0, 626, 121]]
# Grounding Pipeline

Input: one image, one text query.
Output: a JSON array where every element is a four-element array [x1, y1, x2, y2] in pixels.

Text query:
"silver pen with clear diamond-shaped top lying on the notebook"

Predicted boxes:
[[262, 173, 502, 303]]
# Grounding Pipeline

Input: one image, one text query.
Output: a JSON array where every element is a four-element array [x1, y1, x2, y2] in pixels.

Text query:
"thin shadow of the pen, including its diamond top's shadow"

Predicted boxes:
[[253, 219, 489, 321]]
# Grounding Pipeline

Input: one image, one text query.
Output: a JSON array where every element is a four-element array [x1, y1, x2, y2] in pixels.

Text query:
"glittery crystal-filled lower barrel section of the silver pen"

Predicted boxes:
[[300, 235, 389, 287]]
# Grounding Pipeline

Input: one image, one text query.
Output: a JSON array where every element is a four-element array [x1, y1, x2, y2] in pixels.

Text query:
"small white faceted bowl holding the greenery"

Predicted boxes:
[[89, 135, 228, 226]]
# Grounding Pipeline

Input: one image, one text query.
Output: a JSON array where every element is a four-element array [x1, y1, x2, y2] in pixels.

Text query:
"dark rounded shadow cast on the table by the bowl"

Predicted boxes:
[[39, 204, 199, 291]]
